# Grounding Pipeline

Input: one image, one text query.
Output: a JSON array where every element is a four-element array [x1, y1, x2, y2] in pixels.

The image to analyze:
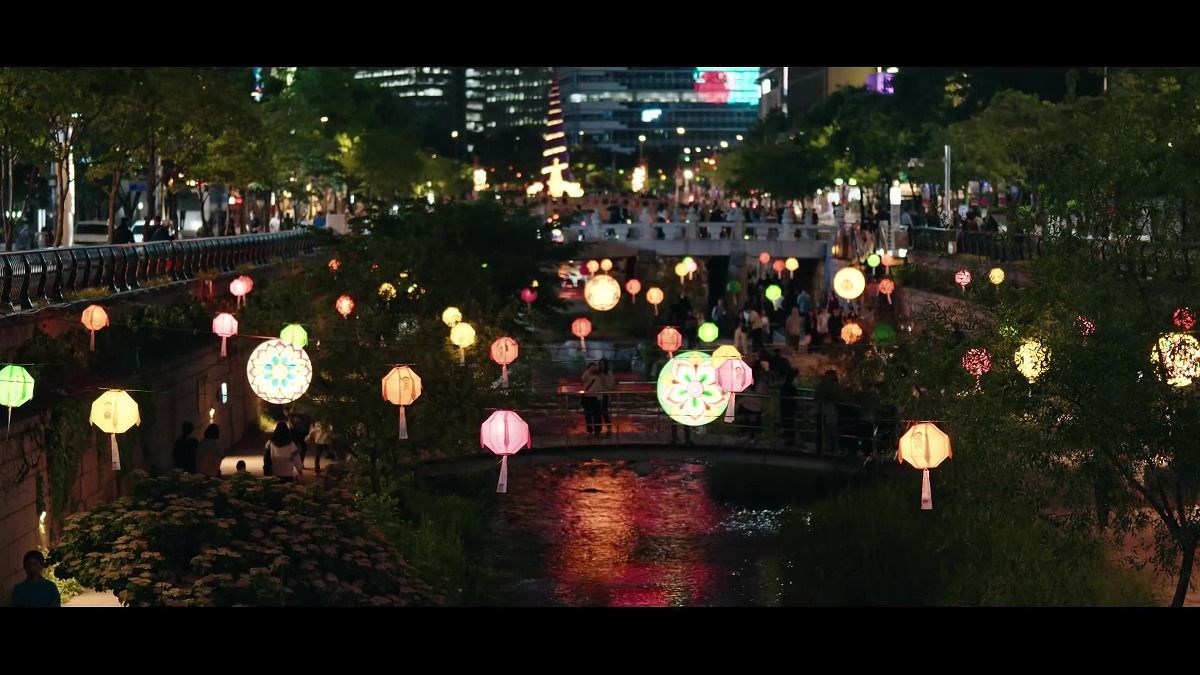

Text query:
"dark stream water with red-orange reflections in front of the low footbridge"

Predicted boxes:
[[482, 460, 782, 607]]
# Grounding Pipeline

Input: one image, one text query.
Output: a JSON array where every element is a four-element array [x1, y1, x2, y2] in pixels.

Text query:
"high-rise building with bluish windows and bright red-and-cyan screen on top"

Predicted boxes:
[[558, 66, 760, 154]]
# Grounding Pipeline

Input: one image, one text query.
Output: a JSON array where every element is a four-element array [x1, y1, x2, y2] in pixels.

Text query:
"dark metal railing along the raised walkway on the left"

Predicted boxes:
[[0, 231, 317, 312]]
